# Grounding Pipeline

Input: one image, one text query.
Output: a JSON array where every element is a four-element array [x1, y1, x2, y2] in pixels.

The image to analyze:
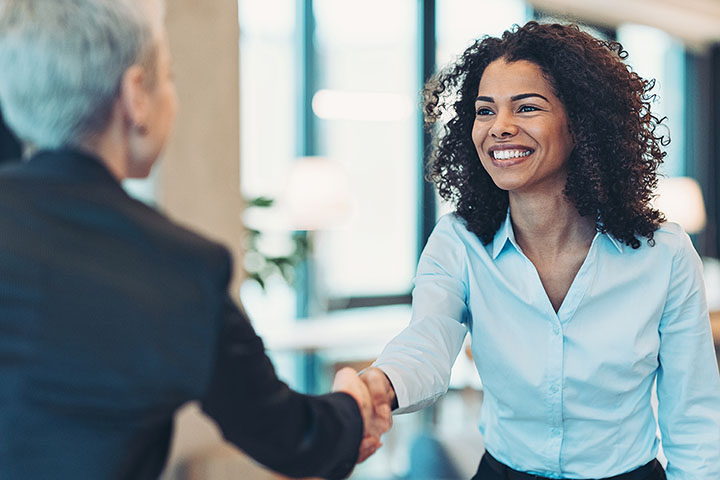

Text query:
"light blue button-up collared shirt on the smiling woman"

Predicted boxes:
[[375, 215, 720, 480]]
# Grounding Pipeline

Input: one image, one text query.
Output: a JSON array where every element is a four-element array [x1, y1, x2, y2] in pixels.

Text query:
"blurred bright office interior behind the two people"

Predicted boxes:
[[0, 0, 720, 480]]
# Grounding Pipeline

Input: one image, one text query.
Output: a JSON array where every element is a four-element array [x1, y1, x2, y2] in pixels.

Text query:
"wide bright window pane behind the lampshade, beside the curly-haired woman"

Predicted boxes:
[[312, 0, 419, 297]]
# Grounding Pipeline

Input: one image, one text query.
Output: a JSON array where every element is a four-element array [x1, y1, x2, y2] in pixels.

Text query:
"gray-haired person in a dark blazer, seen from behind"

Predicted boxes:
[[0, 0, 390, 479]]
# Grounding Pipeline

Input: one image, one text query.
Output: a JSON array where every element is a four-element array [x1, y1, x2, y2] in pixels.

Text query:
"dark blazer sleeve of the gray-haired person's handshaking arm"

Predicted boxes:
[[202, 297, 363, 479]]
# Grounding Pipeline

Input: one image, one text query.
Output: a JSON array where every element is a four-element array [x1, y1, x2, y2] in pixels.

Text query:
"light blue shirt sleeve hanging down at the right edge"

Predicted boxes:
[[657, 235, 720, 480]]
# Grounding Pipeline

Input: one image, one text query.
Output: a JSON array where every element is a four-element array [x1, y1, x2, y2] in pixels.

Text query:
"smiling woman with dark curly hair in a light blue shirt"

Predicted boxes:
[[362, 22, 720, 480]]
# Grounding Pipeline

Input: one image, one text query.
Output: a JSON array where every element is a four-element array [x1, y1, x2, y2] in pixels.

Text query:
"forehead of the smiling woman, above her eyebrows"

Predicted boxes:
[[478, 58, 554, 97]]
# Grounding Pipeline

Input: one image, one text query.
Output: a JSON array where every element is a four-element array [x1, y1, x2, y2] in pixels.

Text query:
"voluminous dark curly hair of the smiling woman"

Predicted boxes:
[[423, 21, 670, 248]]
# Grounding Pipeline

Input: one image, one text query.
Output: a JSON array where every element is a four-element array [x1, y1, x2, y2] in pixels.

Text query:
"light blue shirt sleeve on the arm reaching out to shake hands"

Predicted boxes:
[[373, 216, 468, 413]]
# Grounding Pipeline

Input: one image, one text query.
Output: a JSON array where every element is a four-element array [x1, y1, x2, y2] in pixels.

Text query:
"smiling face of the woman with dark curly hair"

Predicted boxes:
[[472, 58, 573, 197]]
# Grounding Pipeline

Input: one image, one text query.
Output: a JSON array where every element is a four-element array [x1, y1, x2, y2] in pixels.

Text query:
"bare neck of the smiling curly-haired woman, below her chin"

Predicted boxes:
[[510, 188, 595, 257]]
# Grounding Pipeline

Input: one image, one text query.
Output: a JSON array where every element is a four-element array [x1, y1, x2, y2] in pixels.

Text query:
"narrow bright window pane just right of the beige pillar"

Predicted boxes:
[[239, 0, 299, 198]]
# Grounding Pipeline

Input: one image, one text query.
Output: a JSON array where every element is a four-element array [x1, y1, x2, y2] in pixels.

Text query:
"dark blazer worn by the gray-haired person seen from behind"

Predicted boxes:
[[0, 151, 363, 480]]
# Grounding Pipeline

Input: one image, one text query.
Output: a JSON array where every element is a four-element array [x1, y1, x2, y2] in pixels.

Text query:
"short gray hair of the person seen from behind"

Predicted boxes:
[[0, 0, 164, 148]]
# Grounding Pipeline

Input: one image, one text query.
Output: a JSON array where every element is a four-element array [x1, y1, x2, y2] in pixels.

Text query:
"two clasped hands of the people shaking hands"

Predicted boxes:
[[332, 367, 396, 463]]
